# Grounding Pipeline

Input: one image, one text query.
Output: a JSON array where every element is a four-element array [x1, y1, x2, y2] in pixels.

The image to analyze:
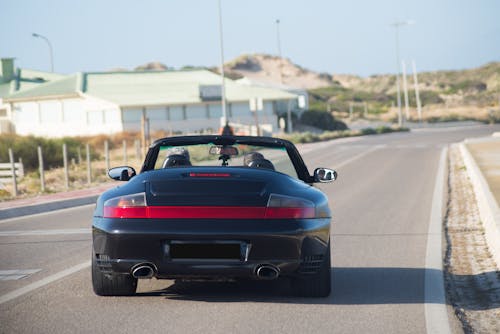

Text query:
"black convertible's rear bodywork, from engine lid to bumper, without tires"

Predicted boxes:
[[93, 167, 330, 279]]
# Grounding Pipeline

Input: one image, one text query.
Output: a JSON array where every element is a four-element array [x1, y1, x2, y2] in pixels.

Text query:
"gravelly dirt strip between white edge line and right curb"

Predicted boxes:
[[444, 145, 500, 333]]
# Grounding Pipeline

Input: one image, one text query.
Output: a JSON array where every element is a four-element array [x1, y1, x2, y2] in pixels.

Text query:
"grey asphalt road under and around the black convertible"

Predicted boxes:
[[0, 126, 500, 333]]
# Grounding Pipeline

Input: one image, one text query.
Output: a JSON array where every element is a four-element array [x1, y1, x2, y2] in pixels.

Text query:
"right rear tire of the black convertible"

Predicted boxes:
[[292, 243, 331, 297]]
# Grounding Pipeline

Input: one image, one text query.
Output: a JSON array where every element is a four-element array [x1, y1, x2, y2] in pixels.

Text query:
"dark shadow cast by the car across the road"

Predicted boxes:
[[134, 267, 500, 309]]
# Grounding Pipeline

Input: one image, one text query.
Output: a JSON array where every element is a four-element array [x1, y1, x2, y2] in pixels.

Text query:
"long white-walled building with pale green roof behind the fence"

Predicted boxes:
[[4, 70, 298, 137]]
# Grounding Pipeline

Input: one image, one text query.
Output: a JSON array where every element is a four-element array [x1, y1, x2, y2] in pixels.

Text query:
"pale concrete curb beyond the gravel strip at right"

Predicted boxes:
[[459, 143, 500, 270]]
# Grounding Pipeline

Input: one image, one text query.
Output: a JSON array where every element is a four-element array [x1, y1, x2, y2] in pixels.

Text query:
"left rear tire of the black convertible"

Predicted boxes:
[[92, 254, 137, 296]]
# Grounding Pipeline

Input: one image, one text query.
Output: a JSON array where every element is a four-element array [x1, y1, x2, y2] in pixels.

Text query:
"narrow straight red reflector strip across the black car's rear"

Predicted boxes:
[[104, 206, 315, 219]]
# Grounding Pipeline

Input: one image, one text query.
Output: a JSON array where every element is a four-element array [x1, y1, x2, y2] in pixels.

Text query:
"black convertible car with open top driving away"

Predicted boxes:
[[92, 136, 337, 297]]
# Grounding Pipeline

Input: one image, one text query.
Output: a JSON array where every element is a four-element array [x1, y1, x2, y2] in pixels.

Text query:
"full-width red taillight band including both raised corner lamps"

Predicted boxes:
[[104, 193, 315, 219]]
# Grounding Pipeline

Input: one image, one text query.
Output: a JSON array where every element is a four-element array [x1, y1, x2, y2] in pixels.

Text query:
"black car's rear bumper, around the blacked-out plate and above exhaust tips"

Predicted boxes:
[[93, 218, 330, 278]]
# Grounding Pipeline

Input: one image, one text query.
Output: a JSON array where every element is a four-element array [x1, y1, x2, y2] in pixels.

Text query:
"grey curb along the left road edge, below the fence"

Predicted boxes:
[[0, 195, 99, 220]]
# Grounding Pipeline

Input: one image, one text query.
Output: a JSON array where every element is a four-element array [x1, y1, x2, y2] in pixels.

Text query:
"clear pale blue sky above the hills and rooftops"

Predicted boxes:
[[0, 0, 500, 76]]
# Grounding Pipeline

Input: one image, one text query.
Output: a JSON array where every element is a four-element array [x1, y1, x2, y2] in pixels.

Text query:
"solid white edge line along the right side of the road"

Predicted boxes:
[[424, 147, 451, 334]]
